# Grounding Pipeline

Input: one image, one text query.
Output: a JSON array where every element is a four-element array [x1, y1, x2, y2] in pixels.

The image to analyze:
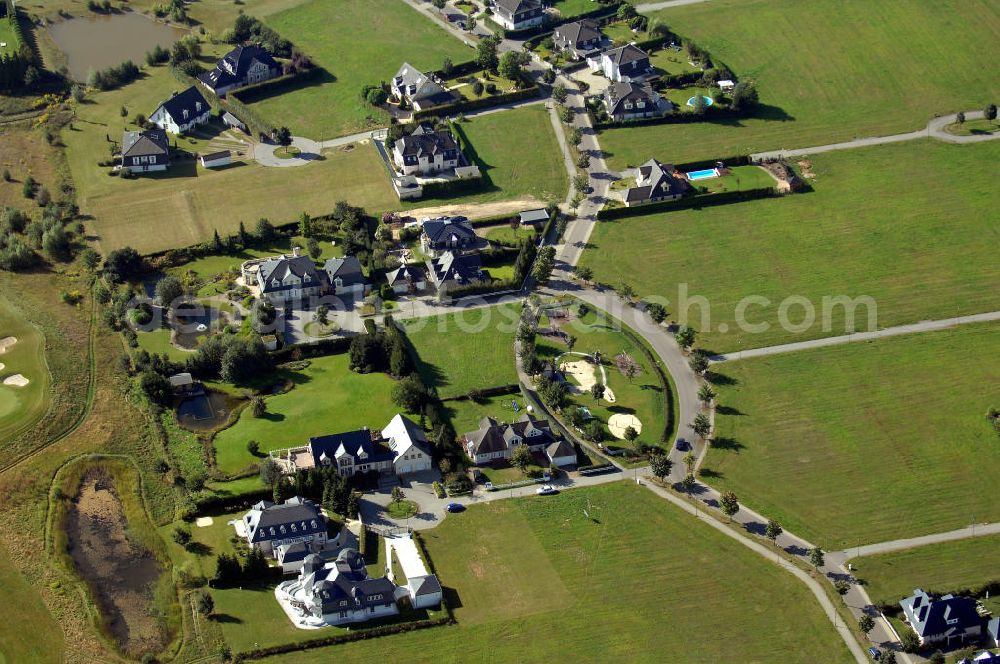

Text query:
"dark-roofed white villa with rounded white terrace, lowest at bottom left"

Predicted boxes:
[[275, 549, 399, 627]]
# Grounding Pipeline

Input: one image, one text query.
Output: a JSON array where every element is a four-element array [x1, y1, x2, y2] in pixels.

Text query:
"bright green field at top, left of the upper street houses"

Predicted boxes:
[[252, 0, 475, 140]]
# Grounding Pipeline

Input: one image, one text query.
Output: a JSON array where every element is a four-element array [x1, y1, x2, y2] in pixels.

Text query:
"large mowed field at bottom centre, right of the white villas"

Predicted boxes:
[[256, 482, 853, 664]]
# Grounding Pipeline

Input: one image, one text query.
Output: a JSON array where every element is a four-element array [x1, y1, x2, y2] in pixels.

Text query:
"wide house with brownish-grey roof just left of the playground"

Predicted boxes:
[[463, 413, 576, 466]]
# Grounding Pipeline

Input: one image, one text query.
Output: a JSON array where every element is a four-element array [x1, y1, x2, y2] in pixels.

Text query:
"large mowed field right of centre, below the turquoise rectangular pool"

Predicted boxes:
[[581, 141, 1000, 352]]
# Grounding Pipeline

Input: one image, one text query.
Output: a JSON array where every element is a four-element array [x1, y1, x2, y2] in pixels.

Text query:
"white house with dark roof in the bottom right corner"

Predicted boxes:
[[899, 588, 983, 648]]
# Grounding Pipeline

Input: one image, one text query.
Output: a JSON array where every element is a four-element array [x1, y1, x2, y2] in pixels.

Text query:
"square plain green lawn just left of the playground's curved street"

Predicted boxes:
[[399, 304, 520, 397]]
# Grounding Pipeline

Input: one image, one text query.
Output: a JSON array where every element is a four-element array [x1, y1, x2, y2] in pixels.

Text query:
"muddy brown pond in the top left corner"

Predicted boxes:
[[49, 11, 185, 81]]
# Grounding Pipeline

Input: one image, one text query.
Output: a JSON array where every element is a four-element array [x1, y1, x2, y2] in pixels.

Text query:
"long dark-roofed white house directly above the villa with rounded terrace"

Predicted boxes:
[[243, 496, 327, 555]]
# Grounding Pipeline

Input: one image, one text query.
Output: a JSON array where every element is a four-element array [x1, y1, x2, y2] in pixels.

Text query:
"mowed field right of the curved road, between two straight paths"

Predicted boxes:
[[703, 323, 1000, 550]]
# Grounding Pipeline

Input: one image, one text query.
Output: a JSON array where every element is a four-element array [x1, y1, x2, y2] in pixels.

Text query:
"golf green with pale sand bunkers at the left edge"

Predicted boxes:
[[0, 294, 50, 441]]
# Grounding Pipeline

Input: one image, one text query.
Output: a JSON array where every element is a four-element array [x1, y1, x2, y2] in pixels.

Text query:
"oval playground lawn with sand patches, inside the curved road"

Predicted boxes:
[[535, 302, 669, 445]]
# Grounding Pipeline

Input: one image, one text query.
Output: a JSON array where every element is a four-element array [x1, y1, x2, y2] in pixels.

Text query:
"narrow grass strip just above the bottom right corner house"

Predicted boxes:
[[851, 535, 1000, 615]]
